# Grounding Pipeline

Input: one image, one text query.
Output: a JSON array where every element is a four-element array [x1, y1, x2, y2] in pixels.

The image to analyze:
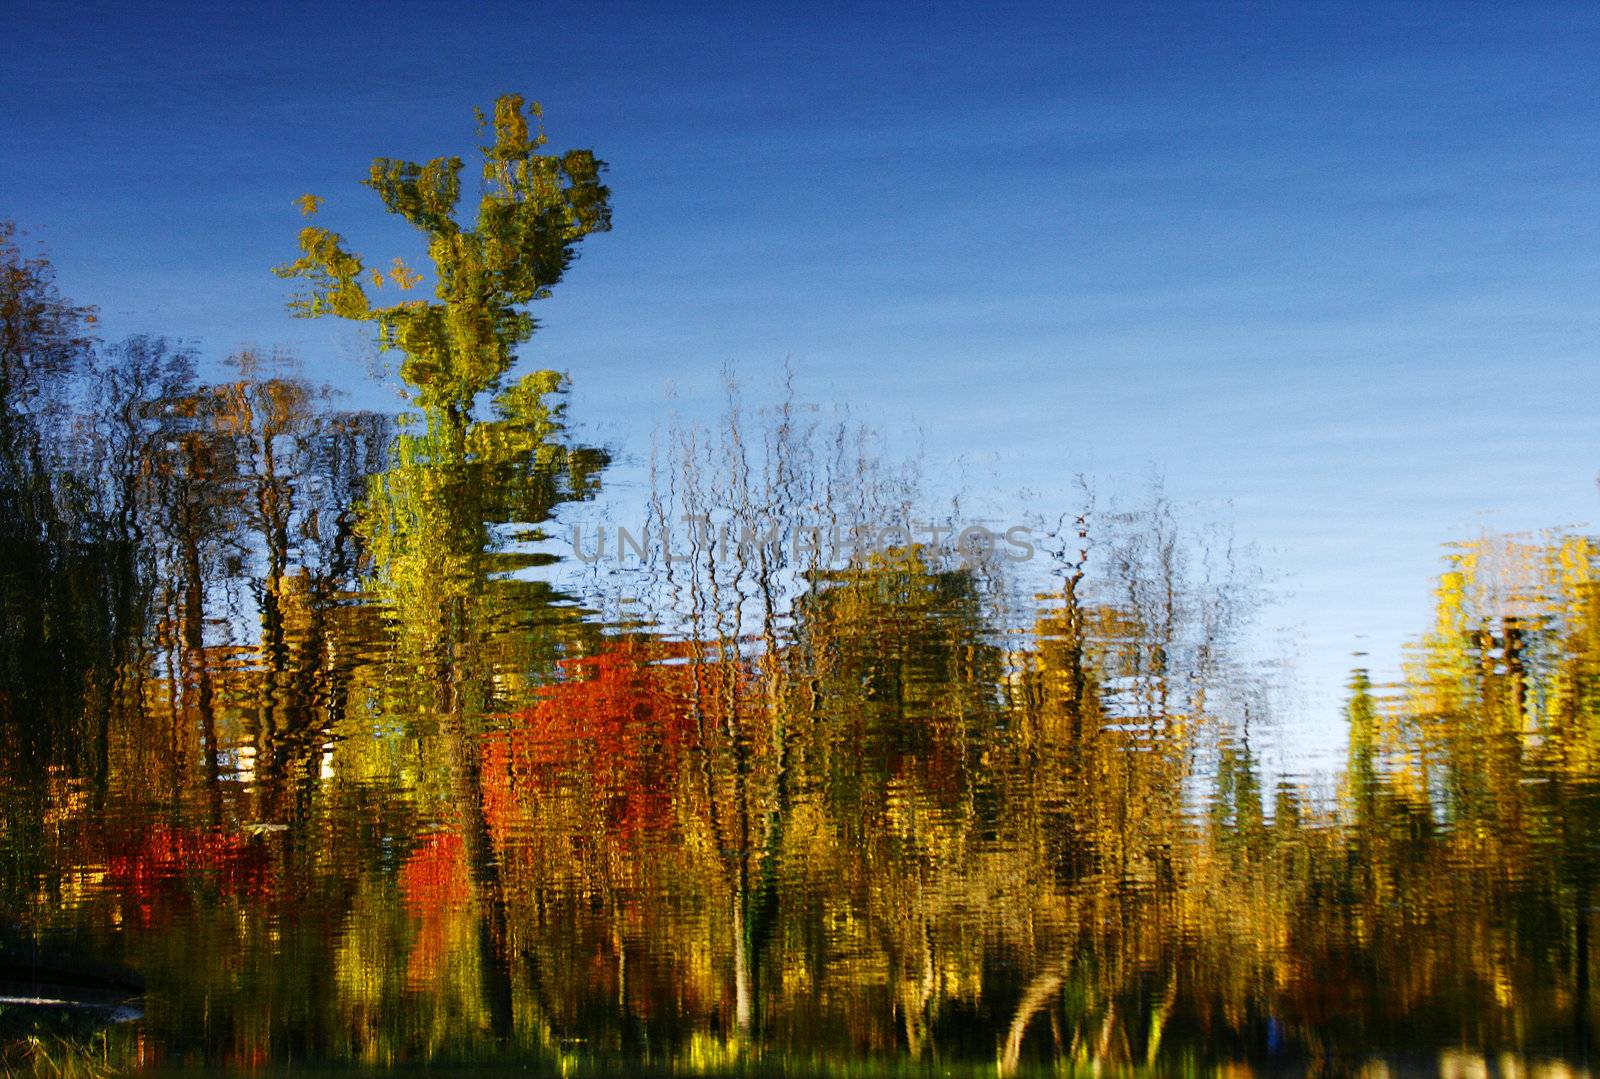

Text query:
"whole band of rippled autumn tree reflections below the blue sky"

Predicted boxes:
[[0, 94, 1600, 1076]]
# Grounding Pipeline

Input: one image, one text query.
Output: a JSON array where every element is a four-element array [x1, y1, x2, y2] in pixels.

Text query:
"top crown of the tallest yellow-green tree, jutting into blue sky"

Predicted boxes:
[[277, 94, 611, 413]]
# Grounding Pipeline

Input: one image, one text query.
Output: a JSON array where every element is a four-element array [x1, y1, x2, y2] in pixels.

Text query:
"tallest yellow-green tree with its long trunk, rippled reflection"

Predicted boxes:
[[278, 94, 610, 1056]]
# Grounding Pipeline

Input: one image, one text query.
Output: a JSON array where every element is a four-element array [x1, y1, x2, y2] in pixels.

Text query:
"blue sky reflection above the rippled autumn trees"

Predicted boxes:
[[0, 3, 1600, 755]]
